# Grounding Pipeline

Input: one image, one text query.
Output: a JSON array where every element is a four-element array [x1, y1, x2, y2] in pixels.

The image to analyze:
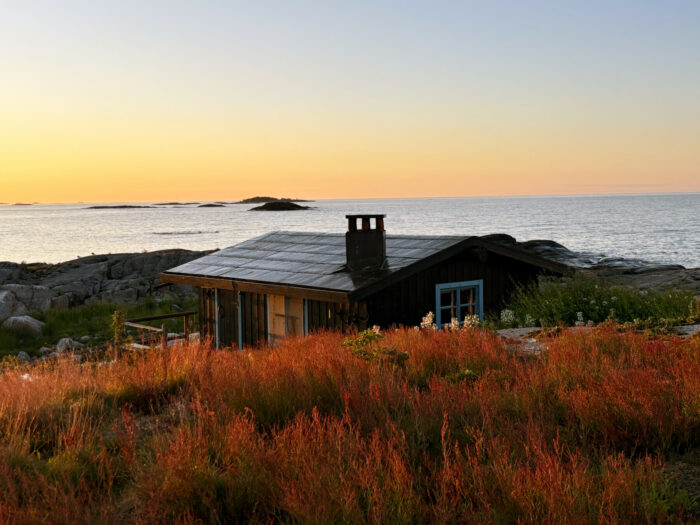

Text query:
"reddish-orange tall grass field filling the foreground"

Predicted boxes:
[[0, 322, 700, 523]]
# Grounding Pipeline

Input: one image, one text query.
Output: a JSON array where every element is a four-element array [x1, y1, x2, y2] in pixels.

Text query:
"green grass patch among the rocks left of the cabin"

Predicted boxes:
[[0, 299, 197, 357]]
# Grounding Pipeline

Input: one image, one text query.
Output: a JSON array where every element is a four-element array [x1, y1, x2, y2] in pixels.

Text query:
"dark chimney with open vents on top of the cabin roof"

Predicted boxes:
[[345, 215, 386, 272]]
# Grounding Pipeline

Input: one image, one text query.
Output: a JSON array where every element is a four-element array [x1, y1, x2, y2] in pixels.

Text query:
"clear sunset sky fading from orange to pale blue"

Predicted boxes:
[[0, 0, 700, 202]]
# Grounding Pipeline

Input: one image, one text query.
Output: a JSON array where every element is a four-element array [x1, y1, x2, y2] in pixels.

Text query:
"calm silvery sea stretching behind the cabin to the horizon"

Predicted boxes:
[[0, 193, 700, 267]]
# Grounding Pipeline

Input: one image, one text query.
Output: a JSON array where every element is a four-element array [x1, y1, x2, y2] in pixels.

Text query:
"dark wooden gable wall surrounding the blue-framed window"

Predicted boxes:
[[365, 250, 543, 327]]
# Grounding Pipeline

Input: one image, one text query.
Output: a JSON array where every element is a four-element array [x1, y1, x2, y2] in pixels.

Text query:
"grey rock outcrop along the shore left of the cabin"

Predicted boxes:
[[0, 250, 210, 322]]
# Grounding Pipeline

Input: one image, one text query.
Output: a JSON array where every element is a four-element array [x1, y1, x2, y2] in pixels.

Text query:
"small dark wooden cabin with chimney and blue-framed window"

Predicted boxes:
[[161, 215, 568, 348]]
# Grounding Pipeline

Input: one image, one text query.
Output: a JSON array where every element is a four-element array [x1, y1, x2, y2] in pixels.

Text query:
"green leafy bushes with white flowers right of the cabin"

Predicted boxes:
[[500, 275, 700, 327]]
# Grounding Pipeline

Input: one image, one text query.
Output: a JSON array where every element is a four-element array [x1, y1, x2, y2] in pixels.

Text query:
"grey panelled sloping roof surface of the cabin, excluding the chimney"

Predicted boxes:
[[167, 231, 468, 292]]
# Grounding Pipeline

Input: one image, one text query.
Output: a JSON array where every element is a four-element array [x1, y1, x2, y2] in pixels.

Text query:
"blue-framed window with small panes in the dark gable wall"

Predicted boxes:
[[435, 279, 484, 328]]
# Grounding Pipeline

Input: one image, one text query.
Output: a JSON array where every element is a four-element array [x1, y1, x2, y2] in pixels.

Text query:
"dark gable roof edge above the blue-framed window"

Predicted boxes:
[[348, 236, 573, 301]]
